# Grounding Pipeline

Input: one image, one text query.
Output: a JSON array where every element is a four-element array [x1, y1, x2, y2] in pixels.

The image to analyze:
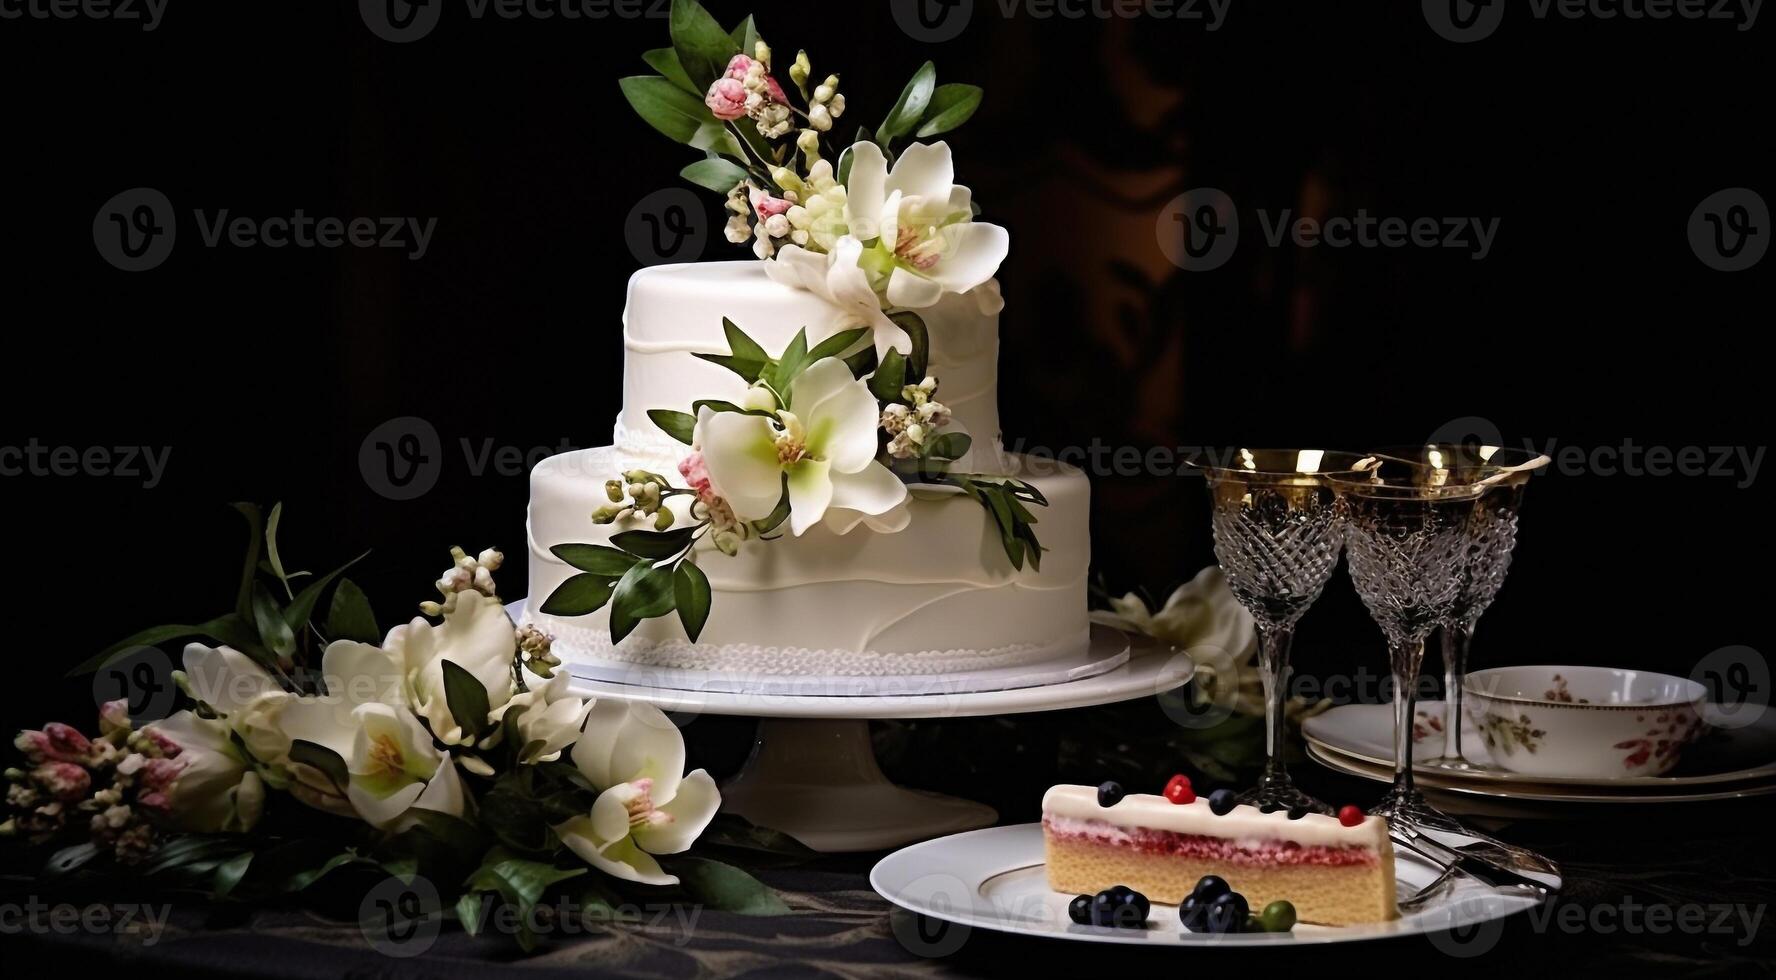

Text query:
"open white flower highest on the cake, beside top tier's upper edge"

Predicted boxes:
[[845, 142, 1011, 309]]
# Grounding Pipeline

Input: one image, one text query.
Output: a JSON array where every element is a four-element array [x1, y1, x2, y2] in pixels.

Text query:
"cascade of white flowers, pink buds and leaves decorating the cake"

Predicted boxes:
[[540, 0, 1048, 643]]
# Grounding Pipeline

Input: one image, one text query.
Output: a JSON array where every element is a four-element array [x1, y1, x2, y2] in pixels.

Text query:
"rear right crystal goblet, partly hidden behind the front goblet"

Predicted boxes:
[[1376, 444, 1549, 769]]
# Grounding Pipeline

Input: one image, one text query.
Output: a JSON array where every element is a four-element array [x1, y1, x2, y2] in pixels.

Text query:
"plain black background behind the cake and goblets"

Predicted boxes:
[[0, 0, 1771, 781]]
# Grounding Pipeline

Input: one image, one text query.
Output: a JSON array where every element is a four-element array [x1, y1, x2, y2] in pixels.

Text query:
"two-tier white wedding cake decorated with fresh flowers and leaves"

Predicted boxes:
[[527, 30, 1090, 676]]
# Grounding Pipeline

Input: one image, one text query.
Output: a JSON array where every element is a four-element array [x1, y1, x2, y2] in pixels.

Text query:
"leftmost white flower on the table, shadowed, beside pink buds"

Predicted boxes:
[[146, 712, 265, 833]]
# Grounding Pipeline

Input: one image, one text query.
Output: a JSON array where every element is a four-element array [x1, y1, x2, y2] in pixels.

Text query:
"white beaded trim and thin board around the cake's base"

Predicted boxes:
[[526, 616, 1062, 676]]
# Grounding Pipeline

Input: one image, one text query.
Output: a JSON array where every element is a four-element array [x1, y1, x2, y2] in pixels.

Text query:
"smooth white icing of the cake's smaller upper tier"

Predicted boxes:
[[616, 261, 1000, 453]]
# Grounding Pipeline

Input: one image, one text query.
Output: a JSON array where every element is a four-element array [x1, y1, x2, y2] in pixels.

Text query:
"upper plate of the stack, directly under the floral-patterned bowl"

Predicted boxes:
[[1302, 701, 1776, 795]]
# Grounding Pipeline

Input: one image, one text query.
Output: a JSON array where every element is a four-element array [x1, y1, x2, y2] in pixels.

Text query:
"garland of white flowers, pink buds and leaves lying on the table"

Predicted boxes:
[[0, 504, 805, 950]]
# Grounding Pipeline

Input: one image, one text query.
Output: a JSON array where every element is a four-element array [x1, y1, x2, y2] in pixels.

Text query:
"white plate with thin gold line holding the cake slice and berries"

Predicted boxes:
[[870, 824, 1559, 946]]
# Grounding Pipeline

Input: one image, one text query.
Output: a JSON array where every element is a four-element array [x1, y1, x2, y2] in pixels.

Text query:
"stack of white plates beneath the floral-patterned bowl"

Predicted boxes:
[[1302, 701, 1776, 817]]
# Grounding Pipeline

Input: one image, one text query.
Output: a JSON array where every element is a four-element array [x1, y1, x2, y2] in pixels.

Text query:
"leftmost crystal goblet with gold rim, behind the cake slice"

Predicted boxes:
[[1192, 449, 1375, 813]]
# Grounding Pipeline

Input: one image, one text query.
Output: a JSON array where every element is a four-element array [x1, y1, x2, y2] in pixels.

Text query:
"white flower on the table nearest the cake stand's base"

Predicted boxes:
[[554, 698, 721, 884]]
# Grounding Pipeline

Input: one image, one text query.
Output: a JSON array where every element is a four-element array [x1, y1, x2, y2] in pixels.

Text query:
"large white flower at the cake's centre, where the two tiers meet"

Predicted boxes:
[[694, 357, 906, 536]]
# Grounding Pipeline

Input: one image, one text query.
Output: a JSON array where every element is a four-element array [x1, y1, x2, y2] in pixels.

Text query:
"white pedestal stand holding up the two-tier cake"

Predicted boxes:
[[511, 600, 1195, 852]]
